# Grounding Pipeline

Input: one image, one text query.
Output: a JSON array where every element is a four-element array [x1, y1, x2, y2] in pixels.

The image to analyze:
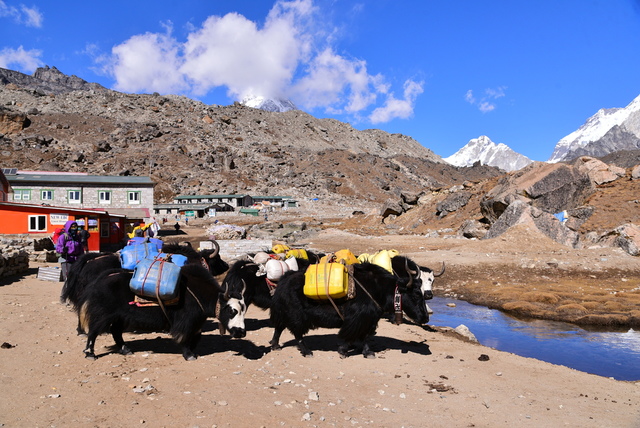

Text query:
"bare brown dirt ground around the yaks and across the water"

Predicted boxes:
[[0, 224, 640, 428]]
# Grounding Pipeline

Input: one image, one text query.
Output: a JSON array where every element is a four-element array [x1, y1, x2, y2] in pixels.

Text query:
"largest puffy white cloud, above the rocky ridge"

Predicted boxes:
[[100, 0, 422, 122]]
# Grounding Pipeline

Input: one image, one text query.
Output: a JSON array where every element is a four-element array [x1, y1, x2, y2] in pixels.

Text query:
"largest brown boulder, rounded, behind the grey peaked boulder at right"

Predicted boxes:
[[480, 162, 595, 223]]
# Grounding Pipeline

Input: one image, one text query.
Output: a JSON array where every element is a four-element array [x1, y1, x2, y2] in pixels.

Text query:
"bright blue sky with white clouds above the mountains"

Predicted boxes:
[[0, 0, 640, 160]]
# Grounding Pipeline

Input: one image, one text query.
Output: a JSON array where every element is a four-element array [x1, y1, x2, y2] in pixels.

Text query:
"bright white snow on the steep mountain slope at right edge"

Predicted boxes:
[[548, 96, 640, 162]]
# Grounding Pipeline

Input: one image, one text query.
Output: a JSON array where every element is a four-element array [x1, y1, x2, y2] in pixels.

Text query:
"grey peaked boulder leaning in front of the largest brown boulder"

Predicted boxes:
[[484, 200, 580, 248]]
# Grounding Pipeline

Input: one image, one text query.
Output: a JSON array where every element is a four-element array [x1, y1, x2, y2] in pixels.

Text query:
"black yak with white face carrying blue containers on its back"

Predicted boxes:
[[79, 245, 246, 360]]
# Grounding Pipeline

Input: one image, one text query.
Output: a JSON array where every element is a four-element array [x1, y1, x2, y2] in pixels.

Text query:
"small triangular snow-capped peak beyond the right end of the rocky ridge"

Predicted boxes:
[[443, 135, 533, 171]]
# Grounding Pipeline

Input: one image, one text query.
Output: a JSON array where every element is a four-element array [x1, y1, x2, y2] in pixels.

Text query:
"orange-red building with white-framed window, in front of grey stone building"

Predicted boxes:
[[0, 201, 126, 251]]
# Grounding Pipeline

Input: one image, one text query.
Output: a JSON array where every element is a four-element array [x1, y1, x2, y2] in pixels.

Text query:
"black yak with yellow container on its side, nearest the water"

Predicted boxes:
[[270, 256, 429, 358]]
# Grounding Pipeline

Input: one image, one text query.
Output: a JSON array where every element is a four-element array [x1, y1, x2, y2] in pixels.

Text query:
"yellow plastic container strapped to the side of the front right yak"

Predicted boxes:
[[304, 263, 349, 300]]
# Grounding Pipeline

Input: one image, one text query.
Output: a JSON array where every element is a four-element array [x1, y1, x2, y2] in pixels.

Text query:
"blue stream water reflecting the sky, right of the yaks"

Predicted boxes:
[[429, 297, 640, 381]]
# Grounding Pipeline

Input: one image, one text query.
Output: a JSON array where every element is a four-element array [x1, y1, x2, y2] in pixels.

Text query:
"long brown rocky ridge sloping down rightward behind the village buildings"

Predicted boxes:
[[0, 68, 500, 206]]
